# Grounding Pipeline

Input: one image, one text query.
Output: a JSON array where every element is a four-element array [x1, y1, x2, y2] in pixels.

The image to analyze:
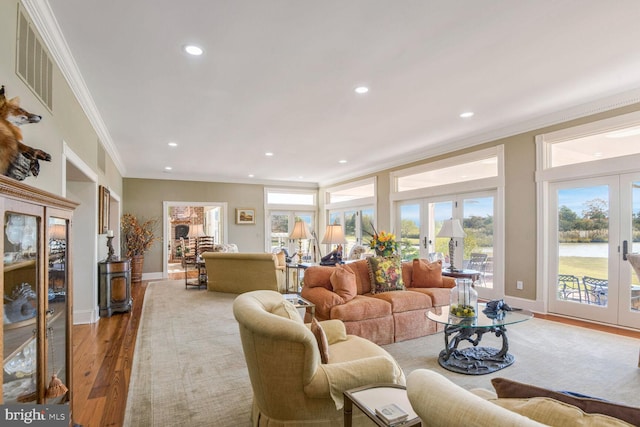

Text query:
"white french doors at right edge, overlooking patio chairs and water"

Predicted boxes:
[[548, 173, 640, 328]]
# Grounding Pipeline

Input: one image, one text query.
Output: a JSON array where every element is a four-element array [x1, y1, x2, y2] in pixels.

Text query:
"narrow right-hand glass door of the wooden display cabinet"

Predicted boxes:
[[45, 217, 70, 403]]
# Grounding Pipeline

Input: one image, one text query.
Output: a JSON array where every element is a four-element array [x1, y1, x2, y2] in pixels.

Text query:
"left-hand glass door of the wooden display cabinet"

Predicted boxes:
[[2, 212, 41, 404]]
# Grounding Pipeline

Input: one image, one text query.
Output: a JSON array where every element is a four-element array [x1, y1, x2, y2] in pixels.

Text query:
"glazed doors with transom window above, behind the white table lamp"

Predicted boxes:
[[391, 145, 504, 299]]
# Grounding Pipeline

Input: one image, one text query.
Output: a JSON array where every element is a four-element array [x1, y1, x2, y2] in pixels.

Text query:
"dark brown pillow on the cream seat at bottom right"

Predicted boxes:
[[491, 378, 640, 424]]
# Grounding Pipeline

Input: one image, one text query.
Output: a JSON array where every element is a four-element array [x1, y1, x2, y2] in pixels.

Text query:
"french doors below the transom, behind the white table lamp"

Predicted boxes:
[[396, 191, 503, 299]]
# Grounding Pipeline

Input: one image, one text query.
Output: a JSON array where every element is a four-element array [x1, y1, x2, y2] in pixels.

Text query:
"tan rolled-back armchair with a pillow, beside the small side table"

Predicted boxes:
[[233, 291, 405, 427]]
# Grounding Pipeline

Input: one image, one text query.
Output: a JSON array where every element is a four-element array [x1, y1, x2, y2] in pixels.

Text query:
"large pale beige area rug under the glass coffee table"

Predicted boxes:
[[125, 280, 640, 427]]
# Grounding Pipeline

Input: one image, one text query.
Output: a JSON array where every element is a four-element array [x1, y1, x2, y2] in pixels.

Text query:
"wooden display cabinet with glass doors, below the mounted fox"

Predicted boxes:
[[0, 176, 77, 419]]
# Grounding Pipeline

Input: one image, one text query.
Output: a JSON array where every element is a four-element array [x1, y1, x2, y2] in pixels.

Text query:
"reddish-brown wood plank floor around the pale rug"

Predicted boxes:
[[73, 275, 640, 427]]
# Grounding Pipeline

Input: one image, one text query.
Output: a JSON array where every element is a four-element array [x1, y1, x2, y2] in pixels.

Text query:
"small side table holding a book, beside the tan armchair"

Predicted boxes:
[[344, 384, 422, 427]]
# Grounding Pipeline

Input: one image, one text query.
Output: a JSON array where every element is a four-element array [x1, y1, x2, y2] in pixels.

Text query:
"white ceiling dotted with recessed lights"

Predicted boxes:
[[33, 0, 640, 184]]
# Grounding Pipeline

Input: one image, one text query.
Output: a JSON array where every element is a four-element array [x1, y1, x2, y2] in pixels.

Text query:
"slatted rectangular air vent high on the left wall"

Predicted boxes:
[[16, 7, 53, 111]]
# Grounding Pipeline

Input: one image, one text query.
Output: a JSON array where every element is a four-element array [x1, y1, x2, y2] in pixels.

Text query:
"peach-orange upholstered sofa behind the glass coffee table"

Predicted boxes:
[[301, 259, 455, 345]]
